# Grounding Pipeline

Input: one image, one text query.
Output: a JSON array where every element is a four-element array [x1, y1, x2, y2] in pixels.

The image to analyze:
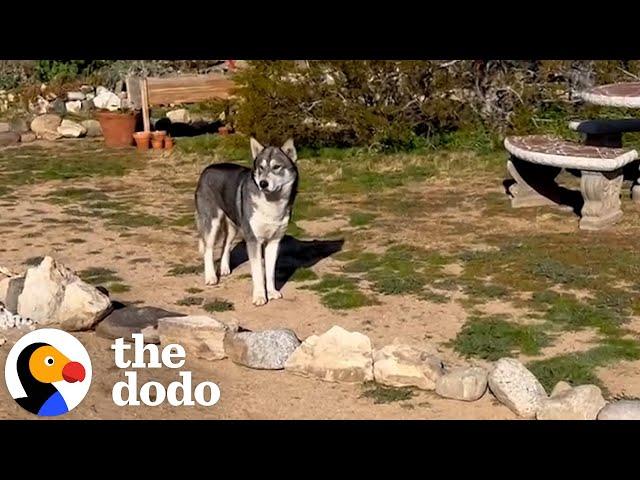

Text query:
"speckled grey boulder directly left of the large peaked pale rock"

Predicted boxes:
[[224, 329, 300, 370]]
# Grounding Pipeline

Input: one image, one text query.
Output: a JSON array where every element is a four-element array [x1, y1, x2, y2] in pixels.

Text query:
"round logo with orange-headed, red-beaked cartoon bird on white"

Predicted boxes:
[[4, 328, 91, 417]]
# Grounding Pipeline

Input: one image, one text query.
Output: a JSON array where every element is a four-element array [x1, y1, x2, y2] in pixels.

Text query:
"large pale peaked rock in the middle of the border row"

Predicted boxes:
[[284, 326, 373, 383]]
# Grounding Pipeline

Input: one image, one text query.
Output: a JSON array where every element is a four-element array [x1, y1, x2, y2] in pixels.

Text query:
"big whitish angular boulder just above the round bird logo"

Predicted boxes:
[[18, 257, 111, 331]]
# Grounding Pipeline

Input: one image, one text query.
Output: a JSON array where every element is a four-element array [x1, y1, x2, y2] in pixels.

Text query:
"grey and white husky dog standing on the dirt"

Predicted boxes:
[[195, 138, 298, 306]]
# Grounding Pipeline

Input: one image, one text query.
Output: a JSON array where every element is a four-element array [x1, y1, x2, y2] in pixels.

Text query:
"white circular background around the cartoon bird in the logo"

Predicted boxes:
[[4, 328, 93, 410]]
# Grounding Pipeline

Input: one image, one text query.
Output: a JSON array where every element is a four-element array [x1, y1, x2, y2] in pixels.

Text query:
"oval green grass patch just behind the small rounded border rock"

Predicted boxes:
[[450, 316, 550, 361]]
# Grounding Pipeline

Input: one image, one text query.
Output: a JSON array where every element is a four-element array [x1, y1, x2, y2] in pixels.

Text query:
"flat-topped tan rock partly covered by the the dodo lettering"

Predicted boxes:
[[158, 315, 230, 360]]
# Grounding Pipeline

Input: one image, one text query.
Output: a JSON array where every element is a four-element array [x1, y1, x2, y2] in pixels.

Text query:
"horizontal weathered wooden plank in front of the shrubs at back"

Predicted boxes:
[[147, 74, 235, 105]]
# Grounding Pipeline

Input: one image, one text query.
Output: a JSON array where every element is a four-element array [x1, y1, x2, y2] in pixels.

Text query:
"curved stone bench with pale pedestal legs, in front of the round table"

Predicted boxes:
[[504, 135, 638, 230]]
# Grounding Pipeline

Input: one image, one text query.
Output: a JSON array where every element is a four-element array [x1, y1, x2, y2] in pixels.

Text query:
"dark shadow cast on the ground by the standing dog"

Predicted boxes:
[[230, 235, 344, 290]]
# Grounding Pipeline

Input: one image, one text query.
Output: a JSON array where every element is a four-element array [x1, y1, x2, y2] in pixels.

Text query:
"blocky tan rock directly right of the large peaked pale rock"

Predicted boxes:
[[373, 344, 444, 390]]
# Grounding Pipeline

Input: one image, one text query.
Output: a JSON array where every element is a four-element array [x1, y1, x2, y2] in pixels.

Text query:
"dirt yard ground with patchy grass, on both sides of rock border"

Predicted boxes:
[[0, 139, 640, 419]]
